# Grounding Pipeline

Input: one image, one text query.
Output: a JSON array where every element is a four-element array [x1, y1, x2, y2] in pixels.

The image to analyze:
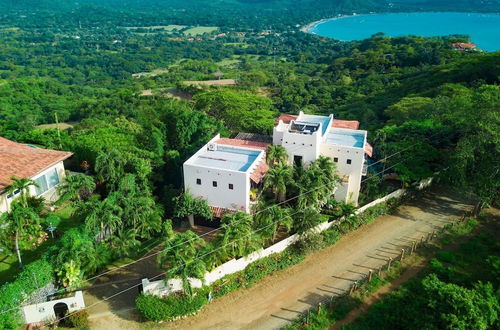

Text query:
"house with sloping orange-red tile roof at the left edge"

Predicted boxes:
[[0, 137, 72, 213]]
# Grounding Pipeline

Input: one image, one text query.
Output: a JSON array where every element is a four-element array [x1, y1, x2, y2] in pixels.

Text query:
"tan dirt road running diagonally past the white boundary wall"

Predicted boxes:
[[91, 187, 472, 329]]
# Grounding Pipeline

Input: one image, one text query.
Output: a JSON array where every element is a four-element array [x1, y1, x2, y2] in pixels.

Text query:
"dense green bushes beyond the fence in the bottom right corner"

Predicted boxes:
[[348, 229, 500, 329]]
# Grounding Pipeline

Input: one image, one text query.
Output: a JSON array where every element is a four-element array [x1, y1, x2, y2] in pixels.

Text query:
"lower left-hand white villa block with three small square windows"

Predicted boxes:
[[183, 135, 270, 217]]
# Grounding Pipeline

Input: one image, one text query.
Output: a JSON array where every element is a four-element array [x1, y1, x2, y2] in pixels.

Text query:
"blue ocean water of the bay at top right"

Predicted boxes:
[[309, 12, 500, 51]]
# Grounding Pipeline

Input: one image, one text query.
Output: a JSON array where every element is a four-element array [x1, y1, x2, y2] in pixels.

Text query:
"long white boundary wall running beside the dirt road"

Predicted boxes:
[[142, 178, 433, 297]]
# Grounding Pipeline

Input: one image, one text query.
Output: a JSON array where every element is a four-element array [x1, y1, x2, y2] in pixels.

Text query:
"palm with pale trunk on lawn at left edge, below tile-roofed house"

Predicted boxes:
[[0, 201, 42, 268]]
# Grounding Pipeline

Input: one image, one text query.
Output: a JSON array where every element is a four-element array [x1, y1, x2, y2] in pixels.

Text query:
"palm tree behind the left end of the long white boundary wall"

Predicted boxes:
[[158, 230, 206, 296]]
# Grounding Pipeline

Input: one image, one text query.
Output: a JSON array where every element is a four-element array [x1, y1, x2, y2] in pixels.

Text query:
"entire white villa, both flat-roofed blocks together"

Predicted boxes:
[[184, 112, 372, 217]]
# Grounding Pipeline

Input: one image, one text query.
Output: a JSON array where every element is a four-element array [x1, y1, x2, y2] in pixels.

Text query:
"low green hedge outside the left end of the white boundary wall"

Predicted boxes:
[[135, 290, 208, 321]]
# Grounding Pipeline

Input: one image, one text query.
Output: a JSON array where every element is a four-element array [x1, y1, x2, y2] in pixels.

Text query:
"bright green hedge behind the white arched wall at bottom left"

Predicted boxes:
[[0, 259, 54, 329]]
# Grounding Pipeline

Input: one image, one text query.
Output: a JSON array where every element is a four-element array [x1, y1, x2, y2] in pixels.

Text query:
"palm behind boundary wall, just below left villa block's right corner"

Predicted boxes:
[[220, 212, 260, 257]]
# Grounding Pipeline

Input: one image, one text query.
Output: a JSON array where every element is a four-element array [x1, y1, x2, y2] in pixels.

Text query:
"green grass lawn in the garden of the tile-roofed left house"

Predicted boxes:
[[0, 205, 81, 285]]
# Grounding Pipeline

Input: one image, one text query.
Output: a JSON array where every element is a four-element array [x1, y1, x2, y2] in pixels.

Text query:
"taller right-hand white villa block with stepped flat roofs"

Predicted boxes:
[[273, 111, 373, 205]]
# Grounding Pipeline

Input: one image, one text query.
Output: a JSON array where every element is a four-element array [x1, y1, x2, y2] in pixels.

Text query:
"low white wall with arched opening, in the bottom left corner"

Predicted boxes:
[[22, 291, 85, 324]]
